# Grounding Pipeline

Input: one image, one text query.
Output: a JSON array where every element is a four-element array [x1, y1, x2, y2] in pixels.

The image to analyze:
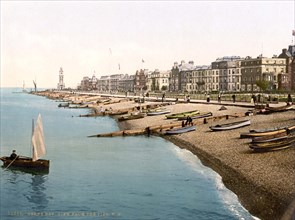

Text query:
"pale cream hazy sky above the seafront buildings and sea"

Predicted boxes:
[[0, 0, 295, 88]]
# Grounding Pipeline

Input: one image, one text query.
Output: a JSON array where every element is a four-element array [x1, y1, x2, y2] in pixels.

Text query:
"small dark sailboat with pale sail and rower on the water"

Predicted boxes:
[[0, 114, 50, 172]]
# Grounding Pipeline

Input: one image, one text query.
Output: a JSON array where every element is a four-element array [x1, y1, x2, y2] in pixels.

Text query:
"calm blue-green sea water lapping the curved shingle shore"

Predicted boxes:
[[0, 89, 253, 220]]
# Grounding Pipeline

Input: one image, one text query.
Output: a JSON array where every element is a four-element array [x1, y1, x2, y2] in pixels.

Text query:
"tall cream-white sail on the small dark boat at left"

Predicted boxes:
[[32, 114, 46, 161]]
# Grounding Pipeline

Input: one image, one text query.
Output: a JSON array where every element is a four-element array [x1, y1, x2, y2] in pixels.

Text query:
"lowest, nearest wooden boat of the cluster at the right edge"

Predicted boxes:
[[249, 135, 295, 152]]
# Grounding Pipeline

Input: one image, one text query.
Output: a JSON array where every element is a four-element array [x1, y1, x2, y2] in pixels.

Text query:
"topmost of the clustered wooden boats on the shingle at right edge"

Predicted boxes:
[[240, 125, 295, 138]]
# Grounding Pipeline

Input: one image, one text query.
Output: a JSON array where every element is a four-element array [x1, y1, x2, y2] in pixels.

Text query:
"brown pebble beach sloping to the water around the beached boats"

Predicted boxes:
[[38, 90, 295, 219]]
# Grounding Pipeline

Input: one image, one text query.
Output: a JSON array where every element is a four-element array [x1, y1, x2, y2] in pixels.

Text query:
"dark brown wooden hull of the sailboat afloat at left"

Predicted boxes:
[[1, 157, 50, 171]]
